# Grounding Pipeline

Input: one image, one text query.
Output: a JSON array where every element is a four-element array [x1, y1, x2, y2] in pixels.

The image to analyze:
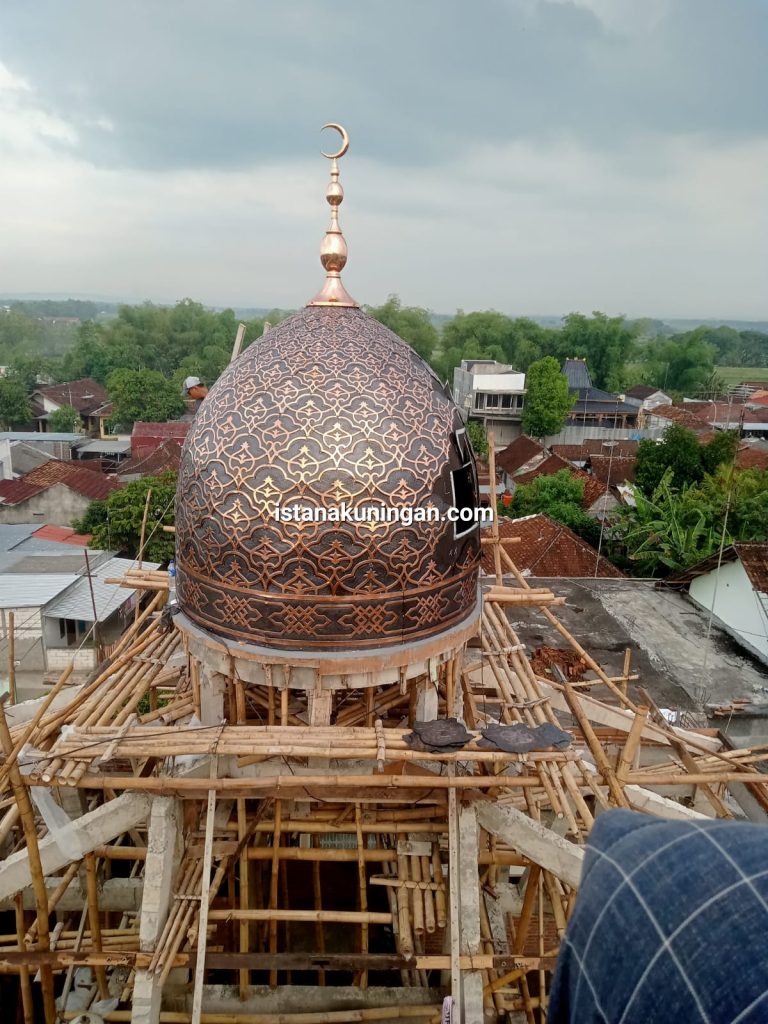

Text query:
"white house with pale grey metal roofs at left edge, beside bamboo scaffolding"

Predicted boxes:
[[0, 523, 159, 676]]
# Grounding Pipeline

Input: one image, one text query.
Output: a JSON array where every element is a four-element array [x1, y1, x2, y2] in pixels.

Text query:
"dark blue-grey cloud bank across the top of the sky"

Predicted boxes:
[[0, 0, 768, 169]]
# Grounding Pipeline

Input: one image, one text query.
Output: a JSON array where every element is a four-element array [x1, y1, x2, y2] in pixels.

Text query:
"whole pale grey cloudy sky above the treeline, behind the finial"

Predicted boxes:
[[0, 0, 768, 319]]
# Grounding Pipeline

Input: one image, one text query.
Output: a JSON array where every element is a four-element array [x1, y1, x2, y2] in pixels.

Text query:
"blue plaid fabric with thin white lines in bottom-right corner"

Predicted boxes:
[[547, 810, 768, 1024]]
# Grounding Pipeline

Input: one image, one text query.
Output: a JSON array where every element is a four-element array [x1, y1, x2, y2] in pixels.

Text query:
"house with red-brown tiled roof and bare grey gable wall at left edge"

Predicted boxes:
[[0, 459, 122, 526]]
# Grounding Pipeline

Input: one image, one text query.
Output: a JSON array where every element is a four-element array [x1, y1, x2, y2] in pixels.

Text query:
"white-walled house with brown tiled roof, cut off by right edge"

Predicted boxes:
[[666, 542, 768, 665]]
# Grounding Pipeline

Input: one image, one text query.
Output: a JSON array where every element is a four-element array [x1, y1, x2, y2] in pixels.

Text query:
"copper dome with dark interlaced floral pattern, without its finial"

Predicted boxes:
[[176, 306, 480, 650]]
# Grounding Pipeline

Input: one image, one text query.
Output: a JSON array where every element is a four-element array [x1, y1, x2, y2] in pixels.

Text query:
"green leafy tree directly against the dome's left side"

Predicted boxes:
[[73, 473, 176, 562]]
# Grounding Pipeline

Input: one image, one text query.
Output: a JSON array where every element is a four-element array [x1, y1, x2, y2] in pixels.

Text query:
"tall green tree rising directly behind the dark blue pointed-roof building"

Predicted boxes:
[[558, 310, 634, 390]]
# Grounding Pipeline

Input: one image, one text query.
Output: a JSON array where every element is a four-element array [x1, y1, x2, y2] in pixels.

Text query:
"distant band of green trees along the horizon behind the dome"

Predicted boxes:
[[0, 296, 768, 396]]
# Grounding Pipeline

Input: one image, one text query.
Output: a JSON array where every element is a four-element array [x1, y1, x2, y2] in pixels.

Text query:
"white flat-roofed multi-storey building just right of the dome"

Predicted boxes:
[[454, 359, 525, 445]]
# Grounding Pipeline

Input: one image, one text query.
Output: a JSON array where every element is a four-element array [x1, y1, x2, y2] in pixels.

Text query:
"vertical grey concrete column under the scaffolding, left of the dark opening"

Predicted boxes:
[[131, 797, 182, 1024]]
